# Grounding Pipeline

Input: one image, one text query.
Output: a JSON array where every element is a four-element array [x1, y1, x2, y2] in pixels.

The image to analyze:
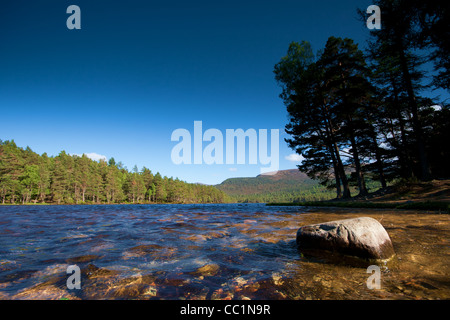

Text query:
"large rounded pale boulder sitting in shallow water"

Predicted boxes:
[[297, 217, 395, 260]]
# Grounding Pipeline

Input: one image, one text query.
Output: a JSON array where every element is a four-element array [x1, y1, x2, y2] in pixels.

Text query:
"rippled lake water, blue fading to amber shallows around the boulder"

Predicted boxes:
[[0, 204, 450, 299]]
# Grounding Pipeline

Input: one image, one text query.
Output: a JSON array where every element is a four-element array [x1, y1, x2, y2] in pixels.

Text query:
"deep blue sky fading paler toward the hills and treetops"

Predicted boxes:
[[0, 0, 426, 184]]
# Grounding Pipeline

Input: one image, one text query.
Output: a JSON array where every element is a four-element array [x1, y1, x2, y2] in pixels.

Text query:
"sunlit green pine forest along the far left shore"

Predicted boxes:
[[0, 140, 229, 204]]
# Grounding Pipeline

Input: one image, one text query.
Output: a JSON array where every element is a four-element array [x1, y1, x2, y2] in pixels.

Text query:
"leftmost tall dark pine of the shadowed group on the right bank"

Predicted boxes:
[[274, 41, 350, 198]]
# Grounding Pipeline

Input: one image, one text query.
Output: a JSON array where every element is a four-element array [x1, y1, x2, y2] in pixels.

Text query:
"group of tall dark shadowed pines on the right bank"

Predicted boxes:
[[274, 0, 450, 198]]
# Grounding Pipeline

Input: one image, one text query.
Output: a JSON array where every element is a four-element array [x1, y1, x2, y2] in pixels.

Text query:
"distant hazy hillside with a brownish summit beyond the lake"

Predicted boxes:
[[215, 169, 334, 202]]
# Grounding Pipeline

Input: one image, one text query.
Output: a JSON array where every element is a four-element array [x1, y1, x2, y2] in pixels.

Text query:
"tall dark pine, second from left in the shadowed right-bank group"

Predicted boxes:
[[318, 37, 375, 195]]
